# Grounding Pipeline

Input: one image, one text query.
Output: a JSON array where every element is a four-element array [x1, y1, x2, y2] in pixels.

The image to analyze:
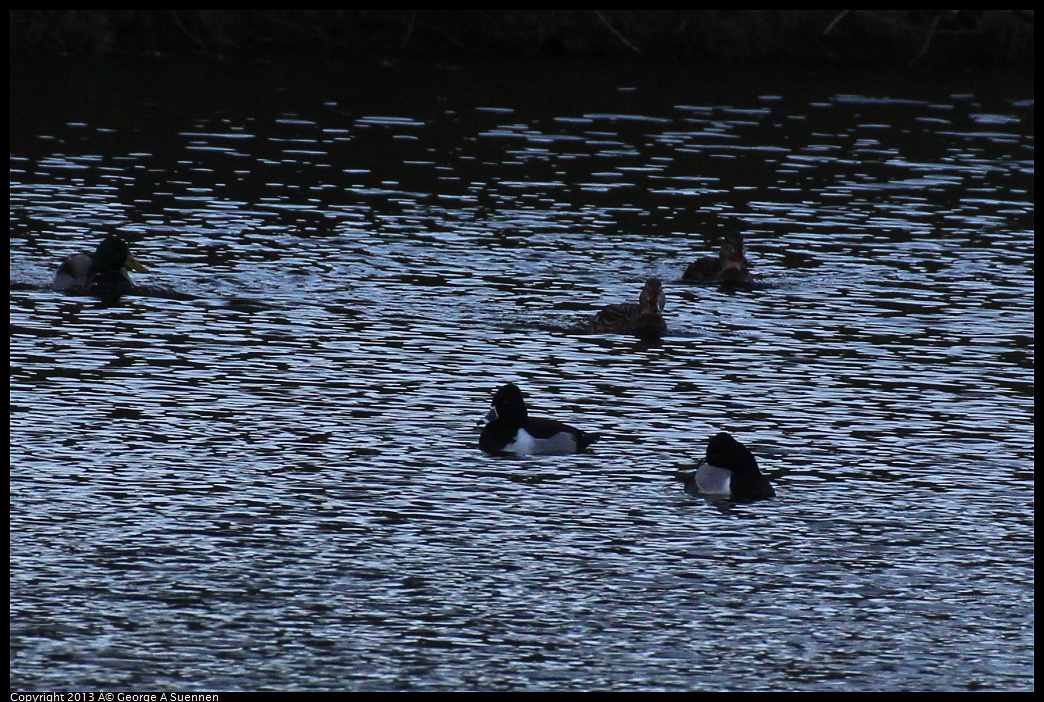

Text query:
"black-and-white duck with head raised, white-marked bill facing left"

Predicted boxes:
[[478, 382, 599, 455]]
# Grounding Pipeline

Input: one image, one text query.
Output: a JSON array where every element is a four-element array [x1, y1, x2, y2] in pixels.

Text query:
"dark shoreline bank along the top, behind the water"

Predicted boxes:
[[9, 9, 1034, 71]]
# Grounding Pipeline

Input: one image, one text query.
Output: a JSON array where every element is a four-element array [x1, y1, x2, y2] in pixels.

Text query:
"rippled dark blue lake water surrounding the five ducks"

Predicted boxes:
[[9, 60, 1035, 692]]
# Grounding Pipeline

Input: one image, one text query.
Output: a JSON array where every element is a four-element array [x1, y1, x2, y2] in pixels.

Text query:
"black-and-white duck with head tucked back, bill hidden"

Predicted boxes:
[[679, 431, 776, 501]]
